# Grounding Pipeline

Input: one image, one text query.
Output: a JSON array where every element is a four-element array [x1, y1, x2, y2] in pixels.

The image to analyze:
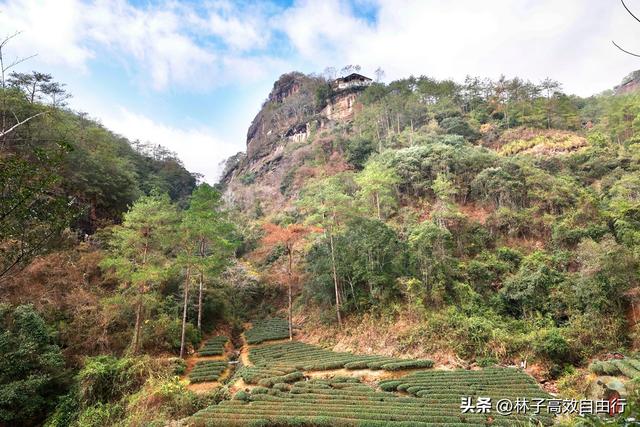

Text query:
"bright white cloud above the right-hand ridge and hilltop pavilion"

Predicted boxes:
[[282, 0, 640, 95]]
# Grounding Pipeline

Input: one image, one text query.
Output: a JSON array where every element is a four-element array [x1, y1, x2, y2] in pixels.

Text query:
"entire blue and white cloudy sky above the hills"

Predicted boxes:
[[0, 0, 640, 182]]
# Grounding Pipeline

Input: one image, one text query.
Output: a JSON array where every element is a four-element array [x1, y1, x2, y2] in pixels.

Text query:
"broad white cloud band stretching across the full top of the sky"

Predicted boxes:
[[0, 0, 640, 94]]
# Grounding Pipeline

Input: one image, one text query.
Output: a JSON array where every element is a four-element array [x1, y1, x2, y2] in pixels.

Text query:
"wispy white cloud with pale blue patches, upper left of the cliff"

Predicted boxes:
[[0, 0, 280, 91]]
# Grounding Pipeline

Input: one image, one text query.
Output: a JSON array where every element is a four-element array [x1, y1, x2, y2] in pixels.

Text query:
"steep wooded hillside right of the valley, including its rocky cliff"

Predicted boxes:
[[223, 74, 640, 392]]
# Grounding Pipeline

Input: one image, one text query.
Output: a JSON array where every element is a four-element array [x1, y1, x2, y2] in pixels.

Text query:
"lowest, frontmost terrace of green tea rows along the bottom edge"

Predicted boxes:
[[190, 371, 552, 427]]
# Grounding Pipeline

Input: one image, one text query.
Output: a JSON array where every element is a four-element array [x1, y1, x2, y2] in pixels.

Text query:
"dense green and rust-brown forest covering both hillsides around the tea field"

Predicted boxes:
[[0, 30, 640, 426]]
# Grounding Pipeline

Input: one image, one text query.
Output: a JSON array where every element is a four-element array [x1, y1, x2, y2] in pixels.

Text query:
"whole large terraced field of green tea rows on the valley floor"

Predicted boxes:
[[188, 319, 553, 427]]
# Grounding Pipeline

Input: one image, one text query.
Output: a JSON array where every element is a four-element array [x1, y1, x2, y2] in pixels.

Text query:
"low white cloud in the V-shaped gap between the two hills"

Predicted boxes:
[[99, 107, 238, 184]]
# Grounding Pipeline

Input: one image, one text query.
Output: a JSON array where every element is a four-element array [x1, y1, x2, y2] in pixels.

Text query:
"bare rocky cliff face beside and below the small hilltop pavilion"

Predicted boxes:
[[221, 72, 364, 214]]
